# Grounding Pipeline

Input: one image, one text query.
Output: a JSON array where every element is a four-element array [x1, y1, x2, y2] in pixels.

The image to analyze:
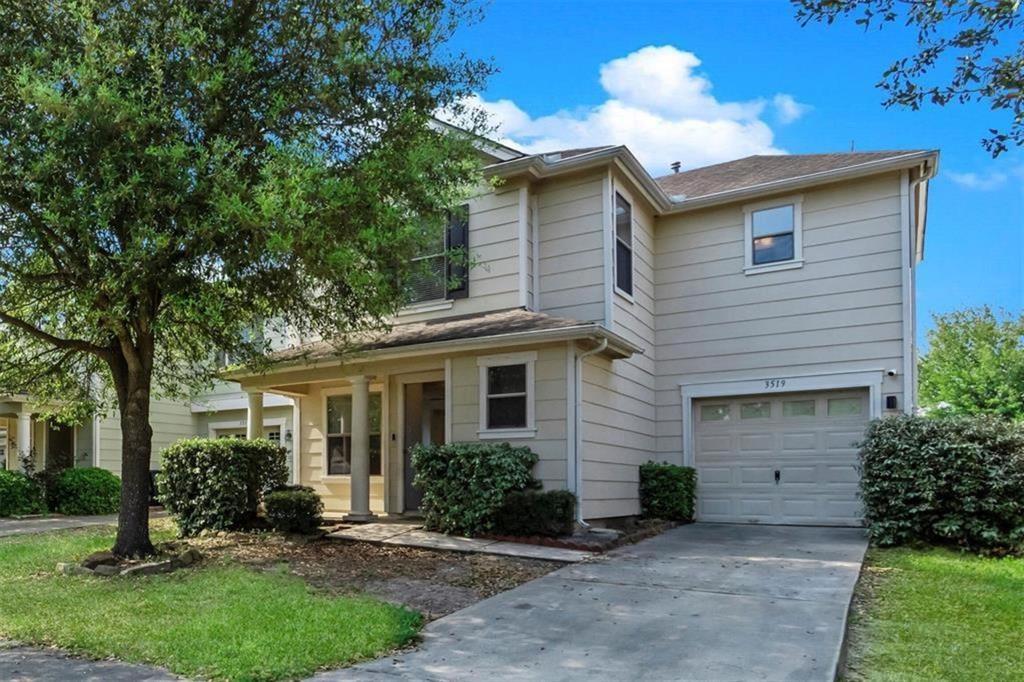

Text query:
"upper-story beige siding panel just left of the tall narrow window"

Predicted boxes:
[[537, 174, 606, 321]]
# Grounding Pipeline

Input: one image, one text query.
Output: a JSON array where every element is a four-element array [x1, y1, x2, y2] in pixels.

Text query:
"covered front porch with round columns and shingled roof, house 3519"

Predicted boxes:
[[226, 309, 633, 521]]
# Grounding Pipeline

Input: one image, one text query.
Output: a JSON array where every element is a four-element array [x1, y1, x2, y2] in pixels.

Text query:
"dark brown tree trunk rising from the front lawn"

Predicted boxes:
[[114, 370, 154, 557]]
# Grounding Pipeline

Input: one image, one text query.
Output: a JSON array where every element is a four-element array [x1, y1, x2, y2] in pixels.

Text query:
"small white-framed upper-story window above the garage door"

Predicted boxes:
[[743, 197, 804, 273]]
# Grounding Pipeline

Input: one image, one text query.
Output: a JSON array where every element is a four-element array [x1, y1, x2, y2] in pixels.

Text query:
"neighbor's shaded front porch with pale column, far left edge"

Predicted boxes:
[[0, 395, 92, 471]]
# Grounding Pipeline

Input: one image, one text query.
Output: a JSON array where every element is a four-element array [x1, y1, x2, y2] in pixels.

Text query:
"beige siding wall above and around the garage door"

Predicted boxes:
[[654, 173, 904, 461]]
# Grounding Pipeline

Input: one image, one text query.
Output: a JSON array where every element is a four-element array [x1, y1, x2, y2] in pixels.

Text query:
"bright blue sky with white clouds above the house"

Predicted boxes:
[[456, 0, 1024, 340]]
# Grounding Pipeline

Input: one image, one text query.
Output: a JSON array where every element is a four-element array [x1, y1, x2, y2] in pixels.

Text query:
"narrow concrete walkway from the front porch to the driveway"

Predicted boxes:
[[327, 522, 596, 563]]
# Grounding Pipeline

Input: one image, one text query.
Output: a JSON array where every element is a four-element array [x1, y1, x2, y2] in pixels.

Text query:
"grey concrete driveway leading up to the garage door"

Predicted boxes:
[[317, 523, 867, 682]]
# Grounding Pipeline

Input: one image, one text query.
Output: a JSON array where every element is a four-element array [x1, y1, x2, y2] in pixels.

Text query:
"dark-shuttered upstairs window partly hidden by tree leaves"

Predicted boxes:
[[408, 205, 469, 304]]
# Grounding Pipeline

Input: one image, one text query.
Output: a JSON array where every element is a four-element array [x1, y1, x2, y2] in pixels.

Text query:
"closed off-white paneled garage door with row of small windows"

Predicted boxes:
[[693, 390, 870, 525]]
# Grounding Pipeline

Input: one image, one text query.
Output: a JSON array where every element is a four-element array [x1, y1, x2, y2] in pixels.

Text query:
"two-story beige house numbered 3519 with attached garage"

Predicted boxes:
[[216, 138, 938, 524]]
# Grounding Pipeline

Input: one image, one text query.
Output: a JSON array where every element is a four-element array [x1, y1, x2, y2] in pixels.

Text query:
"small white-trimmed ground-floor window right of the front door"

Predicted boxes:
[[477, 352, 537, 437]]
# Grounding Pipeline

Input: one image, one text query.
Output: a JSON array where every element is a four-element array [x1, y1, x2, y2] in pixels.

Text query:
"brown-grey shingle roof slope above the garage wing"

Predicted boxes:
[[655, 150, 920, 199]]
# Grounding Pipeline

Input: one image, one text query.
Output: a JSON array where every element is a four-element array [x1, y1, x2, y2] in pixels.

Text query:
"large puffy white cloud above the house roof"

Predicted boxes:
[[469, 45, 808, 175]]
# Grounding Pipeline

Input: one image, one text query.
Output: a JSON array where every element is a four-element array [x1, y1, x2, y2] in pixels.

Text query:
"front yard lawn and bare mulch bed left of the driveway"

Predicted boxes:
[[0, 521, 554, 680]]
